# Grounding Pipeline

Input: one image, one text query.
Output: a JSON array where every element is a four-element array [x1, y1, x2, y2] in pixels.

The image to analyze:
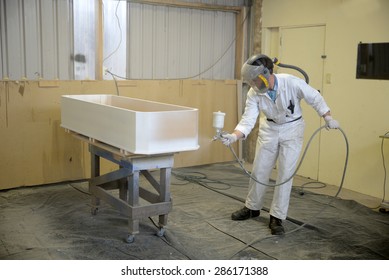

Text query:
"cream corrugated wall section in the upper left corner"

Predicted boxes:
[[0, 0, 73, 79]]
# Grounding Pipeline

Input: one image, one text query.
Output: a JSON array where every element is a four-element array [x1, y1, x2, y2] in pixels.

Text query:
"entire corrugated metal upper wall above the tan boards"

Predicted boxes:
[[0, 0, 244, 80]]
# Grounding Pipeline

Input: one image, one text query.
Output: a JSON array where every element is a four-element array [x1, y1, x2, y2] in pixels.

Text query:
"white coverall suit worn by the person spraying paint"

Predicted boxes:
[[235, 74, 330, 220]]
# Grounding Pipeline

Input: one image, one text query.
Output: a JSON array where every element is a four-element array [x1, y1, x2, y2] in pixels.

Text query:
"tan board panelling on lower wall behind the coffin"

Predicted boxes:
[[0, 80, 238, 189]]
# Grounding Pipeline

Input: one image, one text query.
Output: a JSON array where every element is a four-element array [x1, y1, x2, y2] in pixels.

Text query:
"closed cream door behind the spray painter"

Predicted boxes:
[[277, 26, 325, 180]]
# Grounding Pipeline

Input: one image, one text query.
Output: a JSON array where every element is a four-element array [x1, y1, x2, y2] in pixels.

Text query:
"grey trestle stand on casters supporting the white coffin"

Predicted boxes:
[[89, 144, 174, 243]]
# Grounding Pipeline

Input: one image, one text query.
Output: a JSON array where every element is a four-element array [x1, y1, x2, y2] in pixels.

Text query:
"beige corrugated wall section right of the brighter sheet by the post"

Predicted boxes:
[[128, 4, 236, 79]]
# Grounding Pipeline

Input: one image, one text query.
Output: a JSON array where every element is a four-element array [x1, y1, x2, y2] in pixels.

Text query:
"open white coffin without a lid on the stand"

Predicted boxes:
[[61, 94, 199, 155]]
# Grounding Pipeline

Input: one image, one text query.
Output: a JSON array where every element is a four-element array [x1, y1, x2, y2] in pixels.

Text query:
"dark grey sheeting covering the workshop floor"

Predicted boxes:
[[0, 164, 389, 260]]
